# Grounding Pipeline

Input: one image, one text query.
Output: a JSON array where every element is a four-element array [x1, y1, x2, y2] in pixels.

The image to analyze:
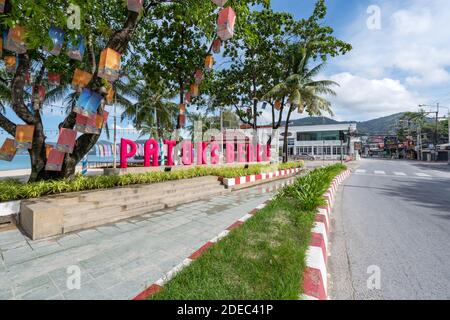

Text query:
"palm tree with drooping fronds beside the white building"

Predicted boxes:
[[265, 44, 339, 162]]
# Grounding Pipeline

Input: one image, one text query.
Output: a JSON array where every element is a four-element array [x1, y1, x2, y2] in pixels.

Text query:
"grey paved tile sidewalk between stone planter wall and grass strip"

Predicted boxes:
[[0, 178, 293, 300]]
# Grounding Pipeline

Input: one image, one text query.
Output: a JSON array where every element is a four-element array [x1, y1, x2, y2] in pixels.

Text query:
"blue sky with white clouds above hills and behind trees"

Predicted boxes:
[[0, 0, 450, 141]]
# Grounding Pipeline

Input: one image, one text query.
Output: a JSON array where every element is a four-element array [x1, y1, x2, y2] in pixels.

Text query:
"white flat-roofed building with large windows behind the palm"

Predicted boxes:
[[279, 120, 360, 160]]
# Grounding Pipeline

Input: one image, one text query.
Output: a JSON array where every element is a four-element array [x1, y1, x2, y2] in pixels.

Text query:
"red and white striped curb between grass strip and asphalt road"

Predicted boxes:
[[302, 170, 351, 300]]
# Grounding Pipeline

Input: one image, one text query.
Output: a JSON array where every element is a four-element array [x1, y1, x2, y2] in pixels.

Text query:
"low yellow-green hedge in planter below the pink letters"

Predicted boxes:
[[0, 162, 303, 202]]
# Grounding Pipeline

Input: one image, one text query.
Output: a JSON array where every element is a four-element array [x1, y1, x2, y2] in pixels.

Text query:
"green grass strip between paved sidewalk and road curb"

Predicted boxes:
[[150, 165, 345, 300]]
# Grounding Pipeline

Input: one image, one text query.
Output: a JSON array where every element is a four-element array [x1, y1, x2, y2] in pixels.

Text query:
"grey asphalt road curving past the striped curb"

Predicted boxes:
[[329, 160, 450, 299]]
